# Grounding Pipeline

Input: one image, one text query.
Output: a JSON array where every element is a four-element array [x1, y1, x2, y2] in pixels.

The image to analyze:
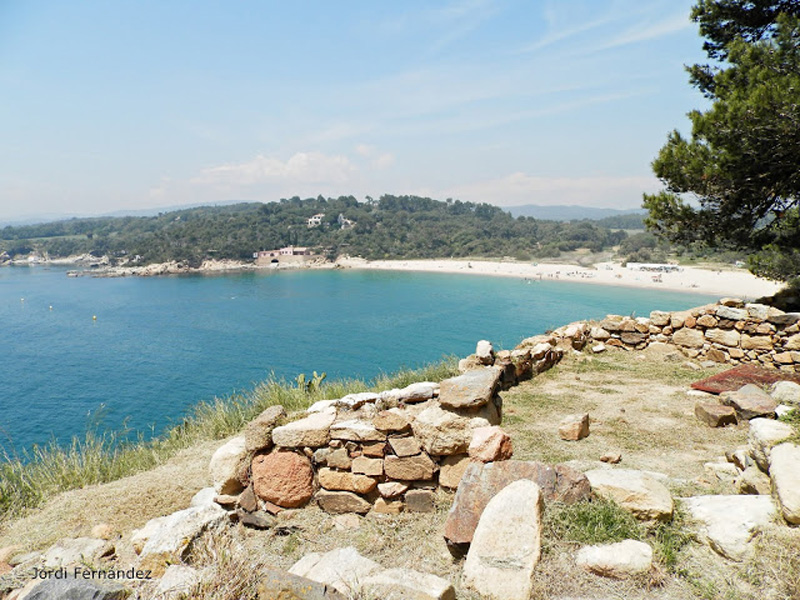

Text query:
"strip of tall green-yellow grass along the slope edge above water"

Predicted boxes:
[[0, 357, 458, 522]]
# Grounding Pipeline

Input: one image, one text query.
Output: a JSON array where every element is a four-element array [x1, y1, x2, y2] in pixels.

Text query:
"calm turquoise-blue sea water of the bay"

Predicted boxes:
[[0, 267, 713, 451]]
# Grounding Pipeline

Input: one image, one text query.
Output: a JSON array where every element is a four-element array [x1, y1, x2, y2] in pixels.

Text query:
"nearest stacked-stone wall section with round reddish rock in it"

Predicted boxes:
[[211, 358, 524, 524]]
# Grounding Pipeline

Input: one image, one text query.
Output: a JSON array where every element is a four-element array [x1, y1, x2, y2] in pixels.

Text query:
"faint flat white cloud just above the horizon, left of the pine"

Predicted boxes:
[[437, 172, 660, 208]]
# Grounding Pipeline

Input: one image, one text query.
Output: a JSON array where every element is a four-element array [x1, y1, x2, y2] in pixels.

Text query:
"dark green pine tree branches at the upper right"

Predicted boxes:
[[644, 0, 800, 281]]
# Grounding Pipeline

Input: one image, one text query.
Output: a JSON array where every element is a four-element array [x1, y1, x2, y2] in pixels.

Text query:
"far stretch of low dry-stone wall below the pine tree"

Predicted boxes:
[[578, 298, 800, 372]]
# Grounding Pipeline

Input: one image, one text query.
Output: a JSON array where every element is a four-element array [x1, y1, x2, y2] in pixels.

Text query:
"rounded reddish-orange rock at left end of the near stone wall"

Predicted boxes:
[[252, 452, 314, 508]]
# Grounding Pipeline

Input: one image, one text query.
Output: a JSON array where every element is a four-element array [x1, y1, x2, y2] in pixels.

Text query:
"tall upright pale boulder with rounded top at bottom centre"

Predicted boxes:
[[462, 479, 543, 600]]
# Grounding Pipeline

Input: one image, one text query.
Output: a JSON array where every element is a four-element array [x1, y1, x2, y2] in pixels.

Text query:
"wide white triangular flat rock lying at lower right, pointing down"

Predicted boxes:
[[682, 495, 776, 561]]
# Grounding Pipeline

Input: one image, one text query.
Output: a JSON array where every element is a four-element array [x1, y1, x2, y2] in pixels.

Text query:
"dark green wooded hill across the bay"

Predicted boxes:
[[0, 195, 626, 266]]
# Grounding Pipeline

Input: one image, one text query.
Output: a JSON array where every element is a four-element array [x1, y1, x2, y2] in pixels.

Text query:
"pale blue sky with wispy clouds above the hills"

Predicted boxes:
[[0, 0, 705, 219]]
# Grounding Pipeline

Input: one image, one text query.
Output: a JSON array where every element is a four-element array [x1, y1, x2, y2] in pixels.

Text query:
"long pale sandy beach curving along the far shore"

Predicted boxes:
[[337, 258, 783, 300]]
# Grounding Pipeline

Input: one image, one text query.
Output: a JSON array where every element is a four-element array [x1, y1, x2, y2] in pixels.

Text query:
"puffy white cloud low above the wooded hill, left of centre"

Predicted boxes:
[[192, 152, 357, 186]]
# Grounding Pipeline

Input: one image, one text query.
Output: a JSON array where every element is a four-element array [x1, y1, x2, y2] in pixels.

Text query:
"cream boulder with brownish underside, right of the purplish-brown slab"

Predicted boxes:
[[585, 469, 674, 521]]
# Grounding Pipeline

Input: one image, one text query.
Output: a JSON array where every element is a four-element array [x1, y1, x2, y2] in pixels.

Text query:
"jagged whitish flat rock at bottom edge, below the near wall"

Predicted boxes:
[[289, 546, 383, 597]]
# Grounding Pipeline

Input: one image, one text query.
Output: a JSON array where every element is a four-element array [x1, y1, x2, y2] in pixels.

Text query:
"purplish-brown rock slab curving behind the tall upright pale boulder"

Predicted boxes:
[[444, 460, 591, 554]]
